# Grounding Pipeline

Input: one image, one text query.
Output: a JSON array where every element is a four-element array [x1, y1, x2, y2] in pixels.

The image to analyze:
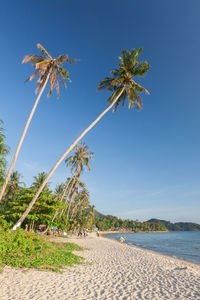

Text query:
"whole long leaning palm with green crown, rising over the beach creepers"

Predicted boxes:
[[12, 48, 149, 230]]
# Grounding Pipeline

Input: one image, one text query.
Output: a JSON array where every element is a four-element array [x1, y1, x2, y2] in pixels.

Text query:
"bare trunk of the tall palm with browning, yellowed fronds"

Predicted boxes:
[[0, 73, 50, 202]]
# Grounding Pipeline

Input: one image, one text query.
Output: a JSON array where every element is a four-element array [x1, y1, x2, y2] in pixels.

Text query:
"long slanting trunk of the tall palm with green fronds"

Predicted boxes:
[[11, 87, 125, 231]]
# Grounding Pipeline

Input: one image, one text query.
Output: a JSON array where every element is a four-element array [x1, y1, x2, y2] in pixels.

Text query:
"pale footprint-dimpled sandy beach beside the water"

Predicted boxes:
[[0, 236, 200, 300]]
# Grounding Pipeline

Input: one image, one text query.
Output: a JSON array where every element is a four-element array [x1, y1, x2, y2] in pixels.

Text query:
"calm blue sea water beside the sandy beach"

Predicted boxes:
[[105, 231, 200, 264]]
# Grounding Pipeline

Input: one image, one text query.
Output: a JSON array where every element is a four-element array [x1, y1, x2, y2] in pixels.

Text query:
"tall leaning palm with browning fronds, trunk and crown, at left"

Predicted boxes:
[[0, 44, 76, 202]]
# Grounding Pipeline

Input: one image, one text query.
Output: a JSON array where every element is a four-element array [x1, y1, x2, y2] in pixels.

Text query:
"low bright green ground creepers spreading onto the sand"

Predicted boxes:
[[0, 228, 82, 271]]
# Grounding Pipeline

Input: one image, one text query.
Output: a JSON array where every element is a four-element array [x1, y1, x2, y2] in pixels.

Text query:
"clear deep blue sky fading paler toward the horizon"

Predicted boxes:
[[0, 0, 200, 223]]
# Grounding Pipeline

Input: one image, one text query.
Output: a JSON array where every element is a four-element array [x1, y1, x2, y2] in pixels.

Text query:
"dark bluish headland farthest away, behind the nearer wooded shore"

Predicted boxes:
[[147, 219, 200, 231]]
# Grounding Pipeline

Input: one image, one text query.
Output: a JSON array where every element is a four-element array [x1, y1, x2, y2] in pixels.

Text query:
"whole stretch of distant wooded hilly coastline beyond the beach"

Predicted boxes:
[[94, 211, 200, 232]]
